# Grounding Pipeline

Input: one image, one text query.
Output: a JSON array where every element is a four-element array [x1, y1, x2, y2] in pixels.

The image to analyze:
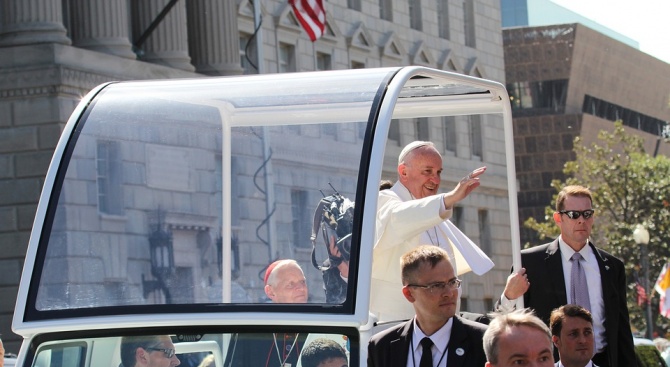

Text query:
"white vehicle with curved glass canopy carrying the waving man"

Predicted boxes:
[[12, 66, 520, 367]]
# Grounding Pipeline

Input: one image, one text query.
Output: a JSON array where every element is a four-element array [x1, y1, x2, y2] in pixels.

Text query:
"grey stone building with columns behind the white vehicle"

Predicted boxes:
[[0, 0, 511, 352]]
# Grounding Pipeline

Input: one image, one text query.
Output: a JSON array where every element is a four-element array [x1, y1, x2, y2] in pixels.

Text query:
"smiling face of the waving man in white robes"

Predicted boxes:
[[398, 147, 442, 199]]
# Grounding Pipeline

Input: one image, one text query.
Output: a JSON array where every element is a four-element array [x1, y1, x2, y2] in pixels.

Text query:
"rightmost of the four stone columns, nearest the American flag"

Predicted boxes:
[[186, 0, 244, 75]]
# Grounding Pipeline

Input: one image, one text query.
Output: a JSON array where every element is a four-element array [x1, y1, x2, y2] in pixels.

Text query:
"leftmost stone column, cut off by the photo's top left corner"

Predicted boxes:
[[0, 0, 70, 46]]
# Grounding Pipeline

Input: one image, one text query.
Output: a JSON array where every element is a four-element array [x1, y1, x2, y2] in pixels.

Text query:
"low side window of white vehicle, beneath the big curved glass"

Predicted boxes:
[[32, 330, 357, 367]]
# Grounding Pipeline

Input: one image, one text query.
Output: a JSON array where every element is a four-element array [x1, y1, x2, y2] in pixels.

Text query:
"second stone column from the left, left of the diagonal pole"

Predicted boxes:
[[70, 0, 136, 59]]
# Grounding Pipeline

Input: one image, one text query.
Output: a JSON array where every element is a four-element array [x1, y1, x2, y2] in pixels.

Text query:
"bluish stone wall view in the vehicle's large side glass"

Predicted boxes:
[[37, 92, 366, 311]]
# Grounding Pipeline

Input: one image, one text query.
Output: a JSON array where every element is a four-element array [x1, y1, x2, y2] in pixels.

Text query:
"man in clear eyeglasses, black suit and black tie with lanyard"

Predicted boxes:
[[368, 245, 486, 367]]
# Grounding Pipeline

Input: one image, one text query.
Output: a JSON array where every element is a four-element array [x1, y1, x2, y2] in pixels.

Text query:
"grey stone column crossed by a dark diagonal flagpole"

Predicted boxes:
[[132, 0, 195, 71]]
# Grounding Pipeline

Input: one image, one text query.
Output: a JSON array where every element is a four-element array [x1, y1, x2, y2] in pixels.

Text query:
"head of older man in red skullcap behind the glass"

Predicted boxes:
[[265, 264, 307, 303]]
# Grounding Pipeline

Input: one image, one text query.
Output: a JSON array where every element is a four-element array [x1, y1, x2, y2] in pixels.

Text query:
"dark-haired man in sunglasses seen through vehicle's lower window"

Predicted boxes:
[[121, 335, 181, 367]]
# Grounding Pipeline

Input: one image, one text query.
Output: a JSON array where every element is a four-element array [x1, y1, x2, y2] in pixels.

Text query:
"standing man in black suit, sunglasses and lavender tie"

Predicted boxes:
[[498, 185, 637, 367]]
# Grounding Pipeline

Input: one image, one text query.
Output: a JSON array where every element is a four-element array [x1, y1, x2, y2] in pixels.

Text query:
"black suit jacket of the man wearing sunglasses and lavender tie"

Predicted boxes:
[[521, 239, 637, 367]]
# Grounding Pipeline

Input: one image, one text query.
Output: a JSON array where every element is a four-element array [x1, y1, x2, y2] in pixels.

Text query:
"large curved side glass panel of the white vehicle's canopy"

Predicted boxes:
[[34, 69, 396, 312]]
